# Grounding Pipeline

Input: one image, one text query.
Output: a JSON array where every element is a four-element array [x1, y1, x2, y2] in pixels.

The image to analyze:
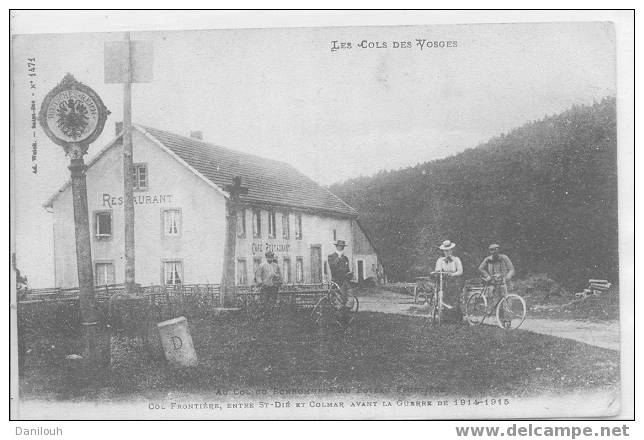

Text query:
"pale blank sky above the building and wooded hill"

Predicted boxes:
[[12, 22, 616, 287]]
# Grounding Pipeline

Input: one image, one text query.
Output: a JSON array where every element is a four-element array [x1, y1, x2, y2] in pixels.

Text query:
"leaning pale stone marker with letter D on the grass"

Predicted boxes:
[[157, 316, 197, 368]]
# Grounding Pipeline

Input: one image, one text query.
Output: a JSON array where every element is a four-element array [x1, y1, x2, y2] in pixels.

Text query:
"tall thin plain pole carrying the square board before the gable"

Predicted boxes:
[[123, 32, 136, 294]]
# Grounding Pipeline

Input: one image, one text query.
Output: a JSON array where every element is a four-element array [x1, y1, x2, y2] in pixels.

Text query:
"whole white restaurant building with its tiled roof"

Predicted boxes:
[[44, 125, 381, 287]]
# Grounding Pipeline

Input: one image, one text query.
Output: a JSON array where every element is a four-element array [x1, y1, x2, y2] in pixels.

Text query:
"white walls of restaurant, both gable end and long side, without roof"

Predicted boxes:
[[53, 130, 377, 287]]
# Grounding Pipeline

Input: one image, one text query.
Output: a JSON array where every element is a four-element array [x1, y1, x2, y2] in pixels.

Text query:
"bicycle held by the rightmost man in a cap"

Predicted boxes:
[[465, 276, 527, 329]]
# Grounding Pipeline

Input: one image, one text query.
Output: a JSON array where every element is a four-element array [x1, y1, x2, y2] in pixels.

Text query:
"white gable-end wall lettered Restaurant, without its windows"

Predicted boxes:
[[53, 130, 225, 287]]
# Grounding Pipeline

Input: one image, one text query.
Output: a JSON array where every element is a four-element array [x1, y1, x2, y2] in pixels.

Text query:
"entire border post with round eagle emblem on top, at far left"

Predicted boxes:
[[38, 73, 110, 366]]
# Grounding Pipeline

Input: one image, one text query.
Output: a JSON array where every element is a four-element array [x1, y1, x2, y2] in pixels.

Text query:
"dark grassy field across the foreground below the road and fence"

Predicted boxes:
[[20, 312, 619, 400]]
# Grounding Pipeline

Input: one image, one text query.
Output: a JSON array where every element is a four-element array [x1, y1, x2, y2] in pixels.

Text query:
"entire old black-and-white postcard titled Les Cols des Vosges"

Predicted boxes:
[[11, 12, 633, 420]]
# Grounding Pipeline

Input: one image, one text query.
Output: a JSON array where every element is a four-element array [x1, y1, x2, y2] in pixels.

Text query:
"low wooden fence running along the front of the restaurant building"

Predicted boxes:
[[18, 284, 328, 337]]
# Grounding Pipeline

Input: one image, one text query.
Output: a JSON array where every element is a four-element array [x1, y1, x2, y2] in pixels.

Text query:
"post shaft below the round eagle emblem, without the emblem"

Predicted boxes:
[[69, 148, 100, 365]]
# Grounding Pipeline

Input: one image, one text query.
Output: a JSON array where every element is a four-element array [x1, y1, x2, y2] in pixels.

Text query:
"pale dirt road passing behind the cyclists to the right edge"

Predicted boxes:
[[359, 291, 619, 351]]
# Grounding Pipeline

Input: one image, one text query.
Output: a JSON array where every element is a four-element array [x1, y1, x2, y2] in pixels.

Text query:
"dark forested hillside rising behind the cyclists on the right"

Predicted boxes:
[[330, 98, 618, 287]]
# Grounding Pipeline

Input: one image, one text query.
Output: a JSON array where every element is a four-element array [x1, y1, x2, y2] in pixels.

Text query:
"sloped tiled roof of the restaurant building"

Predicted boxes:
[[46, 125, 358, 217]]
